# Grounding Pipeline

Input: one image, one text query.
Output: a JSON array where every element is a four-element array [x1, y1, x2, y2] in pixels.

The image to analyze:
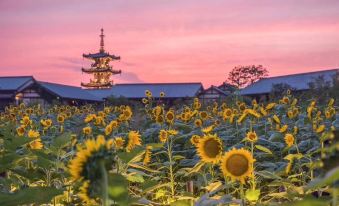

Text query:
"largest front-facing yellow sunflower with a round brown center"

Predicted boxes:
[[220, 148, 255, 184]]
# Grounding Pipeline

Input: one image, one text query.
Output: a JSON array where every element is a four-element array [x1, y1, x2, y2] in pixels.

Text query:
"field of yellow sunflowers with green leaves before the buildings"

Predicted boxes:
[[0, 91, 339, 206]]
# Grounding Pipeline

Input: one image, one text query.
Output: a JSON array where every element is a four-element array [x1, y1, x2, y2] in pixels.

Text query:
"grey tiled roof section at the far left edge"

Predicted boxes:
[[0, 76, 34, 91]]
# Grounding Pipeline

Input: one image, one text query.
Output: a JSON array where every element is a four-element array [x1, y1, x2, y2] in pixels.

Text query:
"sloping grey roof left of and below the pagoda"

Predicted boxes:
[[38, 82, 102, 101]]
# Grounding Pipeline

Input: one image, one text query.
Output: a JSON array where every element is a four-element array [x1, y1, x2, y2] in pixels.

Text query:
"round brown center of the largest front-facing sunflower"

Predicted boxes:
[[226, 154, 249, 176]]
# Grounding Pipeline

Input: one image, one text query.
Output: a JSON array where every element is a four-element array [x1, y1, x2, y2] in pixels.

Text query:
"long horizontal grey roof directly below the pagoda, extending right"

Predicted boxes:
[[88, 83, 203, 99]]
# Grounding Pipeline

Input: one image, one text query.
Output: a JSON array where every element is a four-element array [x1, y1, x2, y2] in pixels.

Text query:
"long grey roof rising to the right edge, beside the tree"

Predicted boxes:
[[240, 69, 339, 95]]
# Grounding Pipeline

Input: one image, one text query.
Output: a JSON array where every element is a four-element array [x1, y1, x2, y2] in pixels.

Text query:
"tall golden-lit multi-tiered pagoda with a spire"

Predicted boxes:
[[81, 29, 121, 89]]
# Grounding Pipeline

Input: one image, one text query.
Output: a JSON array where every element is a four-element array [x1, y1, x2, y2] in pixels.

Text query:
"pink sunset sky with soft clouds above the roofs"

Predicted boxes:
[[0, 0, 339, 87]]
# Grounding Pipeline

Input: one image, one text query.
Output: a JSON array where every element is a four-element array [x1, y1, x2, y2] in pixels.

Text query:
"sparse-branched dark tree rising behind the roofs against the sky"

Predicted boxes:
[[228, 65, 268, 88]]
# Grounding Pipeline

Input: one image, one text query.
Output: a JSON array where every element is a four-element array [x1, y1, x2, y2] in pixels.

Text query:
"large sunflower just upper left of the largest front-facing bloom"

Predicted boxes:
[[197, 134, 223, 163]]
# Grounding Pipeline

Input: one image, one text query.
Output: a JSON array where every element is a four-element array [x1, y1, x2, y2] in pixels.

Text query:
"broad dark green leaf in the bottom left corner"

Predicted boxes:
[[0, 187, 62, 206]]
